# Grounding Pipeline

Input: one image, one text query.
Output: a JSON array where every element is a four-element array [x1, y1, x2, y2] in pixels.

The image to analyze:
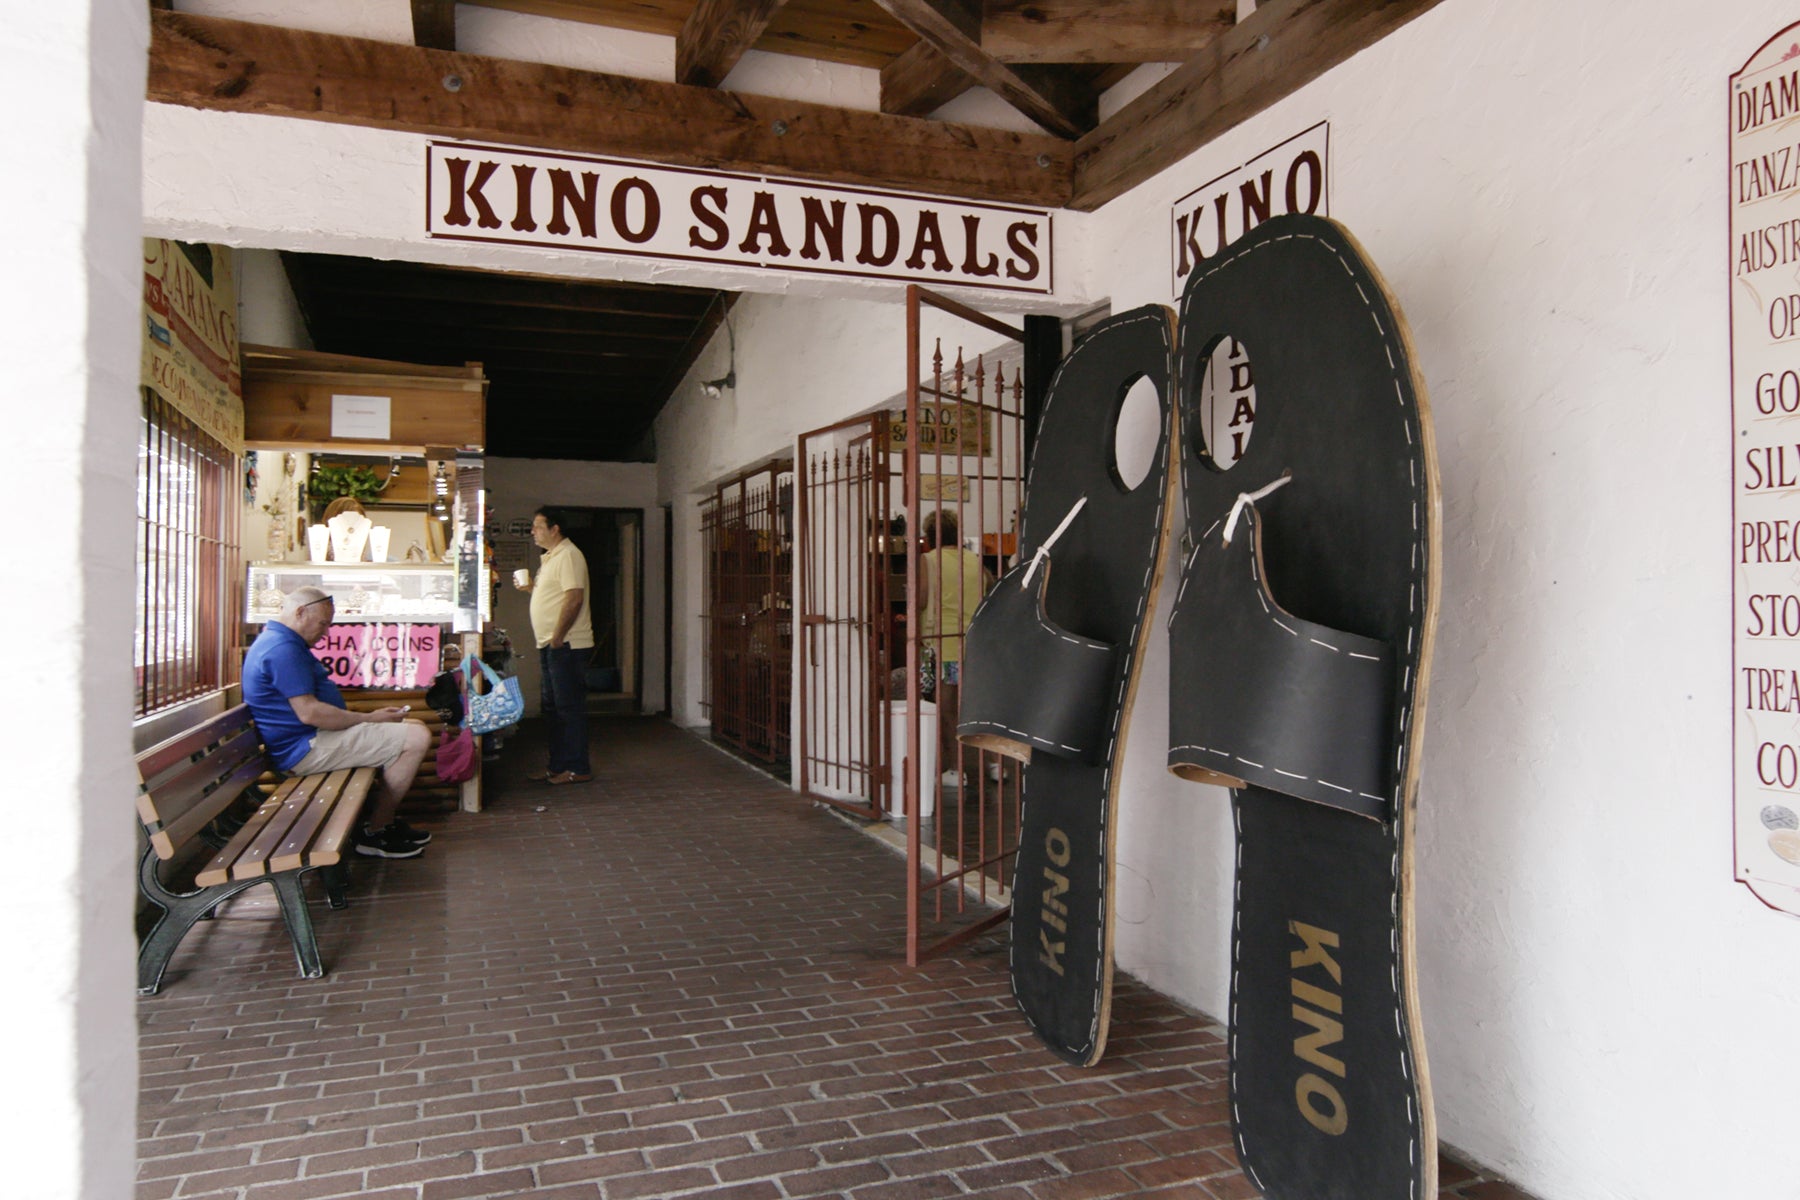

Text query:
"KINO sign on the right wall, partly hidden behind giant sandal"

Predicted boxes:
[[1168, 121, 1332, 297]]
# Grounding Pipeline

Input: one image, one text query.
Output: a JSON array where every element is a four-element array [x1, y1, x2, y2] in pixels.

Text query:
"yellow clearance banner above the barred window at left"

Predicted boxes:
[[140, 237, 243, 453]]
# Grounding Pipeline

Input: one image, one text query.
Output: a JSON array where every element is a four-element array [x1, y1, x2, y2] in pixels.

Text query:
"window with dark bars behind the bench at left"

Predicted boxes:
[[133, 389, 243, 716]]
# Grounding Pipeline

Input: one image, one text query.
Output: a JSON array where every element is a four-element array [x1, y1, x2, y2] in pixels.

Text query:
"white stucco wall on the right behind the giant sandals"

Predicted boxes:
[[1065, 0, 1800, 1200]]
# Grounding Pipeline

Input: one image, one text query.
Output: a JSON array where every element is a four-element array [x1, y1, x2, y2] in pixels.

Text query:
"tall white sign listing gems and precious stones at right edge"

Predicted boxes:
[[1726, 25, 1800, 916]]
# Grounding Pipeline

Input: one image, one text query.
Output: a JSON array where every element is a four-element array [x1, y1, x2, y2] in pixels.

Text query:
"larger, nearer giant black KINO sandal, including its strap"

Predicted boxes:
[[1168, 218, 1438, 1200]]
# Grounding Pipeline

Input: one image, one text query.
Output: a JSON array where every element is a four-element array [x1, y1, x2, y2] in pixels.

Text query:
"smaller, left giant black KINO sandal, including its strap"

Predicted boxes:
[[958, 306, 1174, 1065]]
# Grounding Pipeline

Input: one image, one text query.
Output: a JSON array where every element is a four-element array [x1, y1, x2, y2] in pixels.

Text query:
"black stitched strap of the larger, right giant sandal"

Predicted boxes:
[[1168, 506, 1393, 820]]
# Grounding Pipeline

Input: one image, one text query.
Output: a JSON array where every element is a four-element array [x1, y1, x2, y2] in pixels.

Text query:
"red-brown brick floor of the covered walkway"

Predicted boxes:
[[137, 720, 1523, 1200]]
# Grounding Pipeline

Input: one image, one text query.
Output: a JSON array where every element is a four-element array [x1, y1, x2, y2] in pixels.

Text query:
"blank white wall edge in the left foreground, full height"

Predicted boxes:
[[0, 0, 149, 1200]]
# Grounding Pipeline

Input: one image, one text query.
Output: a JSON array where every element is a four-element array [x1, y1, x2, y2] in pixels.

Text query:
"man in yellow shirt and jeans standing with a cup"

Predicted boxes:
[[522, 507, 594, 784]]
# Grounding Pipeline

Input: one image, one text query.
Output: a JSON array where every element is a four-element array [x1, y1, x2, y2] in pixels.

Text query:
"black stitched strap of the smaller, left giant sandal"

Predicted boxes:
[[956, 561, 1118, 763]]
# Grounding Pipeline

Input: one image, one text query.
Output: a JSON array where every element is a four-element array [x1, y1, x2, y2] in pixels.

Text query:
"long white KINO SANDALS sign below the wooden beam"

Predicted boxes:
[[425, 140, 1053, 295]]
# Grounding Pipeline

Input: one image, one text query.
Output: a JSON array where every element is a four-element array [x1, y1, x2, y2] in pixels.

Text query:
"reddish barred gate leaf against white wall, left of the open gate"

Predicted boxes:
[[796, 414, 904, 820]]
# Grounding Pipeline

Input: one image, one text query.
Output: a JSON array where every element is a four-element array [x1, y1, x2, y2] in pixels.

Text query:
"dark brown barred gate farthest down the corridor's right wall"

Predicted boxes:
[[700, 462, 794, 766]]
